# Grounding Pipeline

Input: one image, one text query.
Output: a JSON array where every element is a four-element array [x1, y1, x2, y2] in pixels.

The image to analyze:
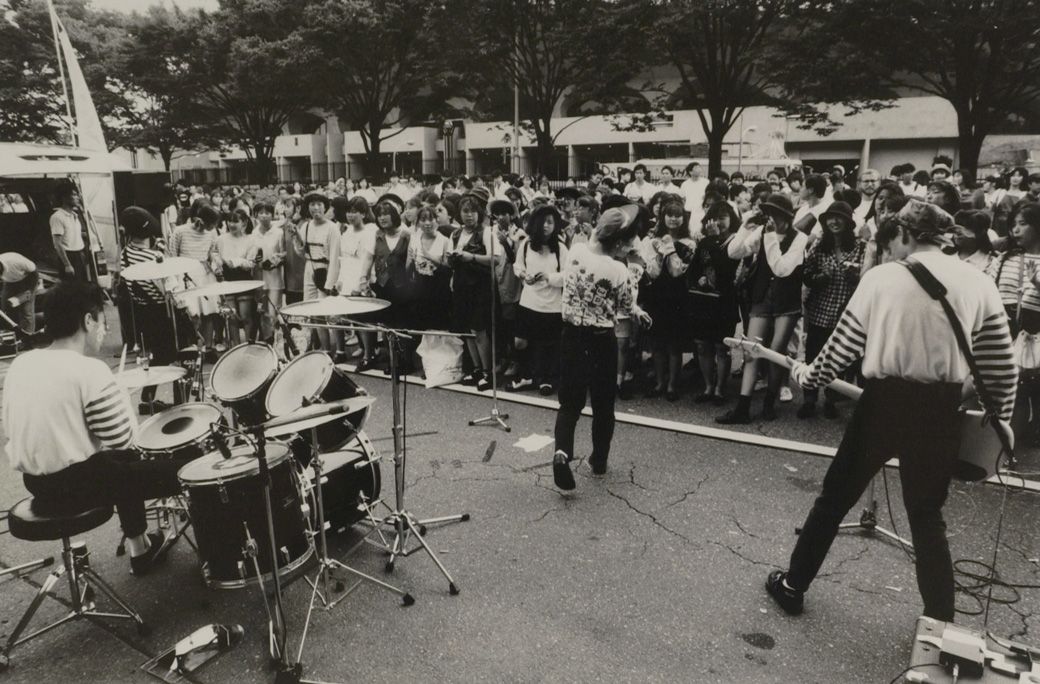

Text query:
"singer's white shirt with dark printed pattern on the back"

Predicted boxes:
[[563, 244, 635, 327]]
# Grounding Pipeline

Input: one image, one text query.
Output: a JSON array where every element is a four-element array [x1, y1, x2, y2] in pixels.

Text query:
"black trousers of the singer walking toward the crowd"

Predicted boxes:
[[555, 323, 618, 465]]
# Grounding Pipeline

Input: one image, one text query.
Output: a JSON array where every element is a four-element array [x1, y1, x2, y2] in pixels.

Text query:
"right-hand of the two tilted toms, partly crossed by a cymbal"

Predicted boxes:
[[266, 351, 368, 452]]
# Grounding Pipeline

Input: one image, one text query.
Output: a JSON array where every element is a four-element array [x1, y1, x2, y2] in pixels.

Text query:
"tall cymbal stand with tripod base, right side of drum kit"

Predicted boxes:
[[287, 316, 469, 596]]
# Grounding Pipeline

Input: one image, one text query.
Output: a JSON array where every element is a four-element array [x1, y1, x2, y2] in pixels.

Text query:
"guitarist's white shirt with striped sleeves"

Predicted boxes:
[[796, 252, 1018, 420]]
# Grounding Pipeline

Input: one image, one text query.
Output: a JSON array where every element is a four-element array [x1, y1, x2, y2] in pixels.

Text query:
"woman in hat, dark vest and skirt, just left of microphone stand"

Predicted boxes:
[[449, 194, 501, 391]]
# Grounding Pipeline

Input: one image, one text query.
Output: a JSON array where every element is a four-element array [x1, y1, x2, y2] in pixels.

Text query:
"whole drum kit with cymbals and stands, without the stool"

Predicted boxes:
[[116, 259, 469, 681]]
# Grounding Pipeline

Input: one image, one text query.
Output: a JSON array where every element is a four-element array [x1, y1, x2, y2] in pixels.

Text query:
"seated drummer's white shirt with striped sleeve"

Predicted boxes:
[[3, 349, 137, 475]]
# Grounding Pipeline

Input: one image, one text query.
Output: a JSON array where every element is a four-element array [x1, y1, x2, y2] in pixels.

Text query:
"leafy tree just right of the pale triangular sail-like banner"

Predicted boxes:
[[107, 6, 220, 172]]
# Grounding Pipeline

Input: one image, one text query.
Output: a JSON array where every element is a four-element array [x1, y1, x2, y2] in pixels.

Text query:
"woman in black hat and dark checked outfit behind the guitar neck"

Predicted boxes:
[[798, 202, 865, 419]]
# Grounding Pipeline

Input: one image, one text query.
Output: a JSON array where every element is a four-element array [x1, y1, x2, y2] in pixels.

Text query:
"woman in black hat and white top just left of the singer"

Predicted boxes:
[[508, 206, 567, 396]]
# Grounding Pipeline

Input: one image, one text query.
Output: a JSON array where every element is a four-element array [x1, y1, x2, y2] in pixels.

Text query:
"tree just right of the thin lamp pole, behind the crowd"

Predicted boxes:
[[449, 0, 646, 169]]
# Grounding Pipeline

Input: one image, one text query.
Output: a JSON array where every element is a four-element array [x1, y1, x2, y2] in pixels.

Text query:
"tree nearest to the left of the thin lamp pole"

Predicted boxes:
[[302, 0, 451, 174]]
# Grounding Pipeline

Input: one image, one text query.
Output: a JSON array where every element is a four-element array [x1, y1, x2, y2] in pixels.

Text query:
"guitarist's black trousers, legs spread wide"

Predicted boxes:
[[787, 377, 961, 622]]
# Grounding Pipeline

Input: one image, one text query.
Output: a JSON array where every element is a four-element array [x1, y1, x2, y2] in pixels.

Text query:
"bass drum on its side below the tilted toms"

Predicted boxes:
[[303, 432, 383, 534]]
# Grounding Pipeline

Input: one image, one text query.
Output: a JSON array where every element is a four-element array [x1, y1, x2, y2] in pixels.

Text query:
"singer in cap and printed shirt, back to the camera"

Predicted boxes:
[[552, 205, 651, 491]]
